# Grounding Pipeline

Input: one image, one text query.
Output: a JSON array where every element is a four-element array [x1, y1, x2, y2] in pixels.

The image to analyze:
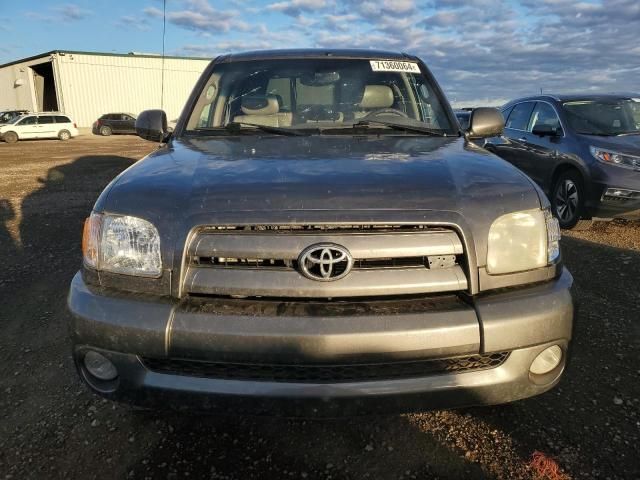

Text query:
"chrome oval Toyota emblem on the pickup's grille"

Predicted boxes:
[[298, 243, 353, 282]]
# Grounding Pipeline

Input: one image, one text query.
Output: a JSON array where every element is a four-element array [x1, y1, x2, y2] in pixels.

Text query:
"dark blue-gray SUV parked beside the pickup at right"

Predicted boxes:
[[485, 95, 640, 228]]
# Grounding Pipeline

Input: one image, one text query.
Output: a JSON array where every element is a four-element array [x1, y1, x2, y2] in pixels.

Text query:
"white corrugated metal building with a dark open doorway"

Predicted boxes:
[[0, 51, 209, 127]]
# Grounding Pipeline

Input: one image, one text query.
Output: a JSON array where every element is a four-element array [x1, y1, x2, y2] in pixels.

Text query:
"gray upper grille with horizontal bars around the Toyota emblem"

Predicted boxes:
[[181, 224, 469, 299]]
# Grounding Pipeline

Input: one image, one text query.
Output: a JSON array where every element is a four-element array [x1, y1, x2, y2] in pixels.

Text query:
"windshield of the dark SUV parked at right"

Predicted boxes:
[[563, 99, 640, 136]]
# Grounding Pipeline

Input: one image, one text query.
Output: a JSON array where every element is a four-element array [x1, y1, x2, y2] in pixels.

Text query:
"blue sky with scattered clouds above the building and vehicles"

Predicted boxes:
[[0, 0, 640, 104]]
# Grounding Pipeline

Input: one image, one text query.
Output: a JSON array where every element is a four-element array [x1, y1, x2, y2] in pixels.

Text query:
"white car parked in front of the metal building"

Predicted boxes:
[[0, 112, 79, 143]]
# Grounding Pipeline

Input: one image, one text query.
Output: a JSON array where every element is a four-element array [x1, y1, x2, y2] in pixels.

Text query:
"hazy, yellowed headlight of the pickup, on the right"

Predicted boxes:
[[487, 208, 560, 275]]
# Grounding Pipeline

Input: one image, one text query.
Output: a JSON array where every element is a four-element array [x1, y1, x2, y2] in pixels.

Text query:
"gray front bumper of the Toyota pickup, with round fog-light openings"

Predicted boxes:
[[68, 270, 573, 416]]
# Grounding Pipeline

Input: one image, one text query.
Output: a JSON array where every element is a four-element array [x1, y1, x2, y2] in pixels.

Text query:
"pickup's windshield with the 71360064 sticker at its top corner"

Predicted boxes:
[[186, 58, 457, 134]]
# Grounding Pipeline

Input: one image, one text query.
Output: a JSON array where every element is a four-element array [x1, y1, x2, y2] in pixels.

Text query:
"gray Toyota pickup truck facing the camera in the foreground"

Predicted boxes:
[[68, 50, 573, 416]]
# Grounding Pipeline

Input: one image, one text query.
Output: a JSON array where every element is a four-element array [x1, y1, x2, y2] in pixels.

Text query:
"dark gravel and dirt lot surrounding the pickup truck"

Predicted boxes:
[[0, 136, 640, 479]]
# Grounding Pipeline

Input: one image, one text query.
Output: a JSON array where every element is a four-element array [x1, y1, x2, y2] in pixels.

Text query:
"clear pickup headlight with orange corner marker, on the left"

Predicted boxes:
[[82, 213, 162, 277]]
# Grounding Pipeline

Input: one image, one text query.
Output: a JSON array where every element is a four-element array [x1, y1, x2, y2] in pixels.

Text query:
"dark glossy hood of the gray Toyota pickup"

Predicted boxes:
[[95, 136, 540, 264]]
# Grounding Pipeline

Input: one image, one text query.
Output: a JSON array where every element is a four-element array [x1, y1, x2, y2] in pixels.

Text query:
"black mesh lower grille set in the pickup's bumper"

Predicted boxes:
[[142, 352, 509, 383]]
